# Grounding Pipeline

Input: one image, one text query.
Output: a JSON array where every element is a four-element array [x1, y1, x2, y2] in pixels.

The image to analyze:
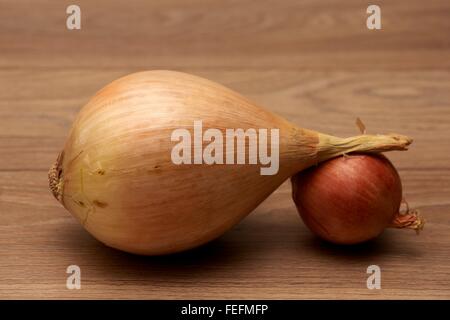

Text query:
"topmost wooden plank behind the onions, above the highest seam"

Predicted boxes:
[[0, 0, 450, 70]]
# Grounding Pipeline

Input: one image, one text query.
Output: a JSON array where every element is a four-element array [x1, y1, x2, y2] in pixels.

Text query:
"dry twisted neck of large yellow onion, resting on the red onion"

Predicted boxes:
[[317, 133, 412, 162]]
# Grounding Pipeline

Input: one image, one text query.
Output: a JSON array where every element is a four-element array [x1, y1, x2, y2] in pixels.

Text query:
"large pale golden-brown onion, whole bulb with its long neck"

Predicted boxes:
[[49, 71, 411, 255]]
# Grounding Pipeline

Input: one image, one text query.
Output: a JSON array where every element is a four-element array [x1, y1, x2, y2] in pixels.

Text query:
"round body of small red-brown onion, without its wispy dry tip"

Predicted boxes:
[[291, 154, 402, 244]]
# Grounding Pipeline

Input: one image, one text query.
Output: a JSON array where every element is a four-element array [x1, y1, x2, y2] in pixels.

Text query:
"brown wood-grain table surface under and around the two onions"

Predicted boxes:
[[0, 0, 450, 299]]
